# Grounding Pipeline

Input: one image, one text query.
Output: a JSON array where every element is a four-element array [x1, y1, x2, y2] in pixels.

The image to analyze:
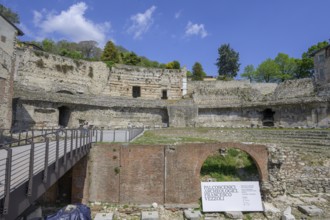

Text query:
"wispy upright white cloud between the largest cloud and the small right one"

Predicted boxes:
[[127, 6, 156, 39]]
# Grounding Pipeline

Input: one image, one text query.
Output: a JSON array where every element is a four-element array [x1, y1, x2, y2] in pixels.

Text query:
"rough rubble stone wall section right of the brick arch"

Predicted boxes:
[[264, 146, 330, 198]]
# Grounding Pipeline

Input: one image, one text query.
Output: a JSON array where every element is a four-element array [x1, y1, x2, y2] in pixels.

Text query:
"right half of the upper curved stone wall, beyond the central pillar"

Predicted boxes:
[[182, 79, 330, 127]]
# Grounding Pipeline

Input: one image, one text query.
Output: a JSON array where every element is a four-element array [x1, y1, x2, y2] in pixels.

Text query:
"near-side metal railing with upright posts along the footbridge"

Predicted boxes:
[[0, 130, 96, 216]]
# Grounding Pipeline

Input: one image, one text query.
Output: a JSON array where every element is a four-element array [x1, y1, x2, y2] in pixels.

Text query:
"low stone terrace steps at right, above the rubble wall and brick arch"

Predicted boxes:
[[154, 128, 330, 155]]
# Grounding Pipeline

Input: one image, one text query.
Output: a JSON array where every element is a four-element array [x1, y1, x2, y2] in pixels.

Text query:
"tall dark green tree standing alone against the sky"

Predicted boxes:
[[216, 44, 240, 79]]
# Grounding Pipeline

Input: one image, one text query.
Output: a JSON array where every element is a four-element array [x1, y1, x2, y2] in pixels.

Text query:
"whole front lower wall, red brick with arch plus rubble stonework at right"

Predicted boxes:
[[80, 143, 330, 204]]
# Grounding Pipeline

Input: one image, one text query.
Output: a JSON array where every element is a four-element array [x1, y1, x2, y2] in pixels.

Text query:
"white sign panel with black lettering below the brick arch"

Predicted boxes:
[[201, 182, 263, 212]]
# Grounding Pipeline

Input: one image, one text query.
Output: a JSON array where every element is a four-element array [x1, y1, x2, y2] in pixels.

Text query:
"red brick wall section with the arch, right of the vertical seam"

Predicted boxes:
[[165, 142, 268, 204]]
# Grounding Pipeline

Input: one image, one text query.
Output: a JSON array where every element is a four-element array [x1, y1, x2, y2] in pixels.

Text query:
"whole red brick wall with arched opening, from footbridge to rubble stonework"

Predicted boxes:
[[72, 143, 268, 204]]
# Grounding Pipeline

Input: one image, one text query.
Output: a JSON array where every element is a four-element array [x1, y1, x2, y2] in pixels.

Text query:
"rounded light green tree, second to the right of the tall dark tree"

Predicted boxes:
[[256, 59, 281, 82]]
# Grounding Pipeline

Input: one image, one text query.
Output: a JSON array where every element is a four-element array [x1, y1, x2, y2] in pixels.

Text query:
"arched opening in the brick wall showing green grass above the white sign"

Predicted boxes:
[[200, 148, 261, 182]]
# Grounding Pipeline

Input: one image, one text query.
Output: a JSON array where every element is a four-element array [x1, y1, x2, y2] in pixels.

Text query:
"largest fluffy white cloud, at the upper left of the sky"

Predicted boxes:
[[33, 2, 111, 45]]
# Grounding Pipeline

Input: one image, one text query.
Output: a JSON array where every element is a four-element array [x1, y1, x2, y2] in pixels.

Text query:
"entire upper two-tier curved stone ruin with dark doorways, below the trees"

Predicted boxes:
[[3, 44, 330, 130]]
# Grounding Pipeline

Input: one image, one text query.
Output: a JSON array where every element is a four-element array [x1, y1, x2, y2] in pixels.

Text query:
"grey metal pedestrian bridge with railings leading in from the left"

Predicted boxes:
[[0, 128, 143, 219]]
